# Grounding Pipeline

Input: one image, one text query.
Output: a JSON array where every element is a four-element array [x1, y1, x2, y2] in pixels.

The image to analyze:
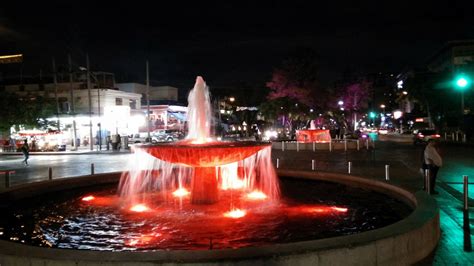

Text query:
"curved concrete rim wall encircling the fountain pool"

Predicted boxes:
[[0, 171, 440, 266]]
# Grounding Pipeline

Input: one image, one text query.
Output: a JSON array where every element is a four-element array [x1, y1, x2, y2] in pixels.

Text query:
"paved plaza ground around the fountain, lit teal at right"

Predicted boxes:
[[0, 136, 474, 265]]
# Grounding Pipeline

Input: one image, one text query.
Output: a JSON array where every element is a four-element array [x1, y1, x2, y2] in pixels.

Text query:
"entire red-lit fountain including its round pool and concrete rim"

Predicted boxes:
[[0, 77, 439, 265]]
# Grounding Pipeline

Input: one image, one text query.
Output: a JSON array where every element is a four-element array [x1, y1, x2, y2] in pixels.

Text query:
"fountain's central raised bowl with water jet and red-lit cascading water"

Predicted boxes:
[[119, 76, 279, 204]]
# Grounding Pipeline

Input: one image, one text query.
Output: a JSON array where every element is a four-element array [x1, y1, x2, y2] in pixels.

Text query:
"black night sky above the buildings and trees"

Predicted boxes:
[[0, 1, 474, 97]]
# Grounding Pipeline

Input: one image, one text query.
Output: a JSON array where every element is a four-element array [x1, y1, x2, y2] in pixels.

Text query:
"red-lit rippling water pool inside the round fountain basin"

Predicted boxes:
[[0, 179, 410, 251]]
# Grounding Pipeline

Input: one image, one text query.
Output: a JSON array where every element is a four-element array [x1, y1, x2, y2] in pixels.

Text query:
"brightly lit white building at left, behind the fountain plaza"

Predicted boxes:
[[5, 72, 145, 150]]
